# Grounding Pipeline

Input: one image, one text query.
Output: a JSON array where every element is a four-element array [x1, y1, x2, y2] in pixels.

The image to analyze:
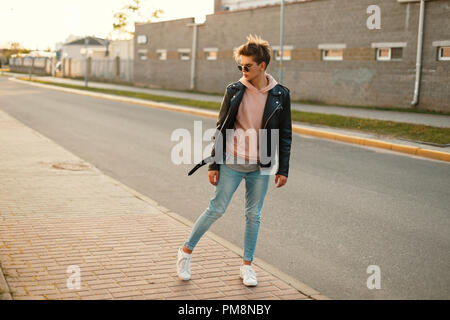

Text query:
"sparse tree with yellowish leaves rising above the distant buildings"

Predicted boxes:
[[107, 0, 164, 40]]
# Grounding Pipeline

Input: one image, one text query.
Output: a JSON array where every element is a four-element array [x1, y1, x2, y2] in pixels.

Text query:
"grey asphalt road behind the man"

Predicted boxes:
[[0, 77, 450, 299]]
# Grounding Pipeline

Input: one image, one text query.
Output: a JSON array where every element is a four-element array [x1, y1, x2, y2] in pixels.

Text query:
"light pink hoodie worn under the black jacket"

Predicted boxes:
[[226, 73, 277, 161]]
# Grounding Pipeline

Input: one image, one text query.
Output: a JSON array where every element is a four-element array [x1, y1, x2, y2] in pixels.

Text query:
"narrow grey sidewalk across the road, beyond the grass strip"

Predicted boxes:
[[5, 72, 450, 128]]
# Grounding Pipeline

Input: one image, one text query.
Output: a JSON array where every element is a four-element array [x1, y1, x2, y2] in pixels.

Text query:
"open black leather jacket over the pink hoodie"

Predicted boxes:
[[188, 81, 292, 177]]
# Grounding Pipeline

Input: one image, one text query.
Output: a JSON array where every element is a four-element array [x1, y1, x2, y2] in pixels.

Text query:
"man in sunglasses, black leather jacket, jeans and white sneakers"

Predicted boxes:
[[177, 35, 292, 286]]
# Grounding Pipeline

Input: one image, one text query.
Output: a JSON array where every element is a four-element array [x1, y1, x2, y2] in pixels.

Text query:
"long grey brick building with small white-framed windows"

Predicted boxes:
[[134, 0, 450, 112]]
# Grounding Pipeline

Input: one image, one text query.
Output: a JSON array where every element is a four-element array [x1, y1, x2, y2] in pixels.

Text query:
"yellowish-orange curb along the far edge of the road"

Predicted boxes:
[[10, 78, 450, 162]]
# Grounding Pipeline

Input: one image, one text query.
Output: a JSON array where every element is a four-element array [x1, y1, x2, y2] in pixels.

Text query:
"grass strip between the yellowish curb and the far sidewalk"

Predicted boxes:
[[21, 78, 450, 145]]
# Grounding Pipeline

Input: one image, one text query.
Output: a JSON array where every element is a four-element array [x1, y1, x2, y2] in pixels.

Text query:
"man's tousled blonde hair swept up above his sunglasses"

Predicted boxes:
[[233, 34, 272, 69]]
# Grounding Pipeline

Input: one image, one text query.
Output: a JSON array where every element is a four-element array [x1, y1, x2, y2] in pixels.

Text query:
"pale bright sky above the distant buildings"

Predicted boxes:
[[0, 0, 214, 50]]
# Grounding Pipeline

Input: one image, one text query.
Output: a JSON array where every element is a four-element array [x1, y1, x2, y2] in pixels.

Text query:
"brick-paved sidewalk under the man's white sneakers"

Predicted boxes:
[[0, 111, 325, 299]]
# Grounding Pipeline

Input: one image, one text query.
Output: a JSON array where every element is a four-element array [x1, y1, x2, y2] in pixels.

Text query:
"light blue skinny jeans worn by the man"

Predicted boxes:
[[185, 164, 270, 261]]
